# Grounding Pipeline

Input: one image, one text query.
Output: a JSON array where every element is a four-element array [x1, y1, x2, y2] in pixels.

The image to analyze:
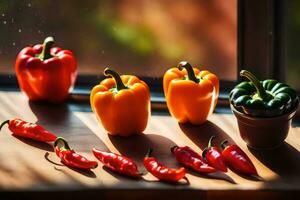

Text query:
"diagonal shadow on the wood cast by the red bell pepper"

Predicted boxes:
[[28, 101, 108, 153]]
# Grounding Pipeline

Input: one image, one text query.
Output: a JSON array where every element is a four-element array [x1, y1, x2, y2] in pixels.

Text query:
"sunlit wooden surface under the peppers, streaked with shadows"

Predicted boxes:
[[0, 92, 300, 199]]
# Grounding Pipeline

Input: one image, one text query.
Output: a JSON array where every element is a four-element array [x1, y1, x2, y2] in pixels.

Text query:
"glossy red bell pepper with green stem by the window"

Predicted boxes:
[[15, 37, 77, 103]]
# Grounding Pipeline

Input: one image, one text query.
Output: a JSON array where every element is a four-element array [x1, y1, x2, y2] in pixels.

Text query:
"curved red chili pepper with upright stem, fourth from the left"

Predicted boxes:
[[144, 149, 187, 182]]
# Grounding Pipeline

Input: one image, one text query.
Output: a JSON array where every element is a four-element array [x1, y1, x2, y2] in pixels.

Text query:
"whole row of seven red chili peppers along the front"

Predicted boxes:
[[0, 118, 259, 182]]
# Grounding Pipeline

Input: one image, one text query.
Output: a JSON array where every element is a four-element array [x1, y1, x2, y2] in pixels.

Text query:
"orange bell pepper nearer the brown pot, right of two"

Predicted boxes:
[[163, 61, 219, 125]]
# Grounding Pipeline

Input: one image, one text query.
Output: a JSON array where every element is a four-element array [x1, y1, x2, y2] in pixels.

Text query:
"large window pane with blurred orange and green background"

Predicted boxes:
[[0, 0, 237, 80]]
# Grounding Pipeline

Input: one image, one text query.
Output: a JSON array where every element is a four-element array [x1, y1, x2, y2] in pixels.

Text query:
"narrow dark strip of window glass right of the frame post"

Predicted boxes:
[[285, 0, 300, 90]]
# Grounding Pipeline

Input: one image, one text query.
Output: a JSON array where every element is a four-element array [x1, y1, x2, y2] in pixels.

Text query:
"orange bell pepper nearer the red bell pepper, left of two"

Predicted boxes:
[[90, 68, 150, 136]]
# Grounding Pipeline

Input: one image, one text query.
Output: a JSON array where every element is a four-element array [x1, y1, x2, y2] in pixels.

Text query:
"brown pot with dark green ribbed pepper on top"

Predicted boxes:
[[229, 70, 299, 148]]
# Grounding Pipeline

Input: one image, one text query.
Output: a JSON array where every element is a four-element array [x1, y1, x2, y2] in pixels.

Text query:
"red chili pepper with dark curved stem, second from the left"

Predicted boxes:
[[54, 137, 98, 169]]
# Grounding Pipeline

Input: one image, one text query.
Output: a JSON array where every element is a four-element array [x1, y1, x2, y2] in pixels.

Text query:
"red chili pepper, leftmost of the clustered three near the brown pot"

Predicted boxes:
[[171, 146, 217, 173]]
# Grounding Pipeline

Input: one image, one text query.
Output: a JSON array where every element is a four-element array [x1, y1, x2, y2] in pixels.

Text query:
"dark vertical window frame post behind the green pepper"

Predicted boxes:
[[238, 0, 286, 81]]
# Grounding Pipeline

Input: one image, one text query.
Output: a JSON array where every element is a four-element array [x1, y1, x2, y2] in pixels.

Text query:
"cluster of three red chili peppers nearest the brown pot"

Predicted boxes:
[[171, 136, 259, 178]]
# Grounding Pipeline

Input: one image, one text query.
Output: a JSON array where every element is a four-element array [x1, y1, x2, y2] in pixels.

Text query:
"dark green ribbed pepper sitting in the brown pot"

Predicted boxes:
[[229, 70, 298, 117]]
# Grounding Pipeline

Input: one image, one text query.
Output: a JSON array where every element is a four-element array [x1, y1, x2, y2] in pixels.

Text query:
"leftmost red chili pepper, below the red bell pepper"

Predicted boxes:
[[0, 118, 57, 142]]
